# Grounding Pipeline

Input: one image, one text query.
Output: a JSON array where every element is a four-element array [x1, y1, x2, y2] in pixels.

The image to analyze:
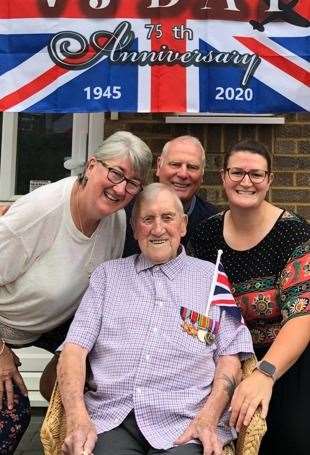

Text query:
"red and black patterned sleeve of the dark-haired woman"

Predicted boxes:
[[278, 240, 310, 324]]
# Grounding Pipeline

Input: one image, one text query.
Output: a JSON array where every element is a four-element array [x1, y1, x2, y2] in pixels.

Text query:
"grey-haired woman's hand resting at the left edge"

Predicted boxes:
[[0, 346, 28, 410]]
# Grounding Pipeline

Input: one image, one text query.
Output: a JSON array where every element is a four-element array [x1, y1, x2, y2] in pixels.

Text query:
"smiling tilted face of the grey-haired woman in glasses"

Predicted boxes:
[[85, 156, 140, 218]]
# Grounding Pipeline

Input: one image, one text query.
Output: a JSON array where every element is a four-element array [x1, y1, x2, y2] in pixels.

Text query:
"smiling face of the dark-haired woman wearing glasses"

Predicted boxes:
[[221, 150, 273, 208]]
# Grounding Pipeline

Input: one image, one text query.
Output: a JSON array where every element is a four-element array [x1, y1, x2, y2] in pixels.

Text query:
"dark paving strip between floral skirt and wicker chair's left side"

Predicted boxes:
[[14, 408, 46, 455]]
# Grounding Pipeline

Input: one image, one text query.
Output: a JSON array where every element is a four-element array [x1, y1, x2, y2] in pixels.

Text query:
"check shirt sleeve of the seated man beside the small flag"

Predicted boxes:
[[215, 309, 254, 360]]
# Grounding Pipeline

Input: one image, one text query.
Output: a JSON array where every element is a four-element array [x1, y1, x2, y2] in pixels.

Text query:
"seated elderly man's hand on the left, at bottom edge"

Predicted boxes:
[[62, 415, 97, 455]]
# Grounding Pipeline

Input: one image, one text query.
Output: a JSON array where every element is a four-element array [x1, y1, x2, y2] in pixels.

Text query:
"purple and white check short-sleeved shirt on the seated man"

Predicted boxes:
[[66, 249, 253, 449]]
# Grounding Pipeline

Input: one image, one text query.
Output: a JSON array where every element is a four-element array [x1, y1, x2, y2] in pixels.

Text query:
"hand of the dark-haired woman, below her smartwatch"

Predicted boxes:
[[229, 370, 273, 431]]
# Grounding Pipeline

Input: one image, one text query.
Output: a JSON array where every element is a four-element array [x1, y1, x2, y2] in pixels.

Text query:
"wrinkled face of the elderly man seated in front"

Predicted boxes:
[[134, 191, 187, 264]]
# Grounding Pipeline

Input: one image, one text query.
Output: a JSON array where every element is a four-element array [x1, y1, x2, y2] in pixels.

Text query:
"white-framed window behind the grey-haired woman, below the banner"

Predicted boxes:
[[0, 113, 104, 201]]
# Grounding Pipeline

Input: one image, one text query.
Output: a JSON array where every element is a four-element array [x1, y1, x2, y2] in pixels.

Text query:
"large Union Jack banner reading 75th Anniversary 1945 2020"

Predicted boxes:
[[0, 0, 310, 114]]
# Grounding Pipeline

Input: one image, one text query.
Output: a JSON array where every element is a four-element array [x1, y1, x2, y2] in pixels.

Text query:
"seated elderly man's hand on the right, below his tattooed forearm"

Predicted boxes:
[[175, 414, 223, 455]]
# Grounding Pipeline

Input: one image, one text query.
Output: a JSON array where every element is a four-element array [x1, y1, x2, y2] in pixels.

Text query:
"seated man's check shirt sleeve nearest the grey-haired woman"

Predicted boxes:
[[62, 265, 106, 352]]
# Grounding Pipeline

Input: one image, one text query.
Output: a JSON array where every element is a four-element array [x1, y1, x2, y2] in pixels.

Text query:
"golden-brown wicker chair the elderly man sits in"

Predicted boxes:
[[41, 357, 267, 455]]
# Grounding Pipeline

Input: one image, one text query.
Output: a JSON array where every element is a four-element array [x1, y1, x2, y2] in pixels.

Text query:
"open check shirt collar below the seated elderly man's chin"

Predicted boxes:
[[135, 245, 187, 280]]
